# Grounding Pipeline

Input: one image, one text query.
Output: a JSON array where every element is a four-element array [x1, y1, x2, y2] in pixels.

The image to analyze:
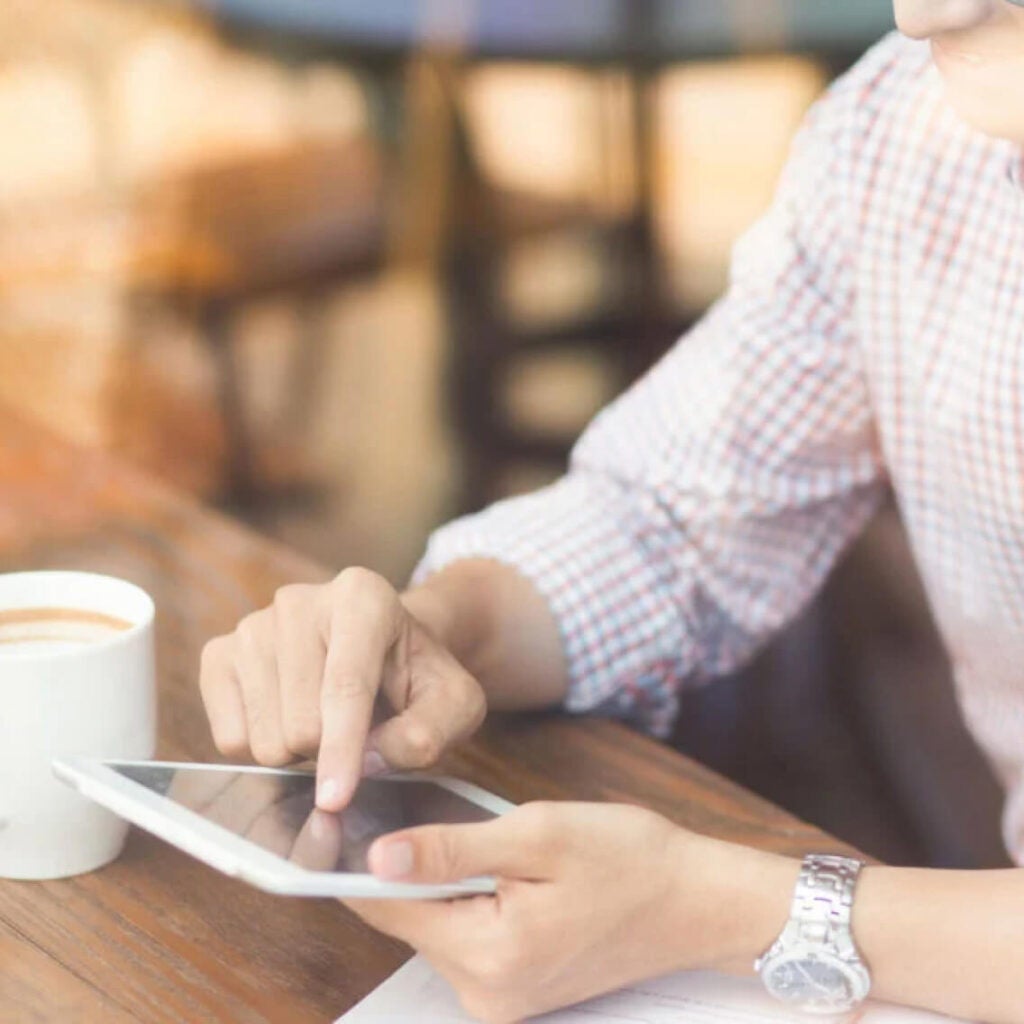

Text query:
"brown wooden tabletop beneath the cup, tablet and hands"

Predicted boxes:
[[0, 409, 843, 1024]]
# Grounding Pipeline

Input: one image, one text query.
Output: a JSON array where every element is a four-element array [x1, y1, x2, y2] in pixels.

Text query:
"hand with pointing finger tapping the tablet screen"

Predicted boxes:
[[200, 568, 486, 811]]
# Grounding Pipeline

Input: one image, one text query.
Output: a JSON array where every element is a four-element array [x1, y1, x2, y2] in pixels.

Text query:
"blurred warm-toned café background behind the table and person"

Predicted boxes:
[[0, 0, 1005, 865]]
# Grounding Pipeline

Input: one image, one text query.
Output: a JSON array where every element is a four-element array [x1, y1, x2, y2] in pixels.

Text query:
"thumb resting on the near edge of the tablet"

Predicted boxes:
[[368, 805, 554, 885]]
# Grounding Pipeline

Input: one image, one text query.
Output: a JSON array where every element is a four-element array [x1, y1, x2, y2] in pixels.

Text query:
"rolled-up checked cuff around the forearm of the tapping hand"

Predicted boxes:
[[413, 472, 693, 736]]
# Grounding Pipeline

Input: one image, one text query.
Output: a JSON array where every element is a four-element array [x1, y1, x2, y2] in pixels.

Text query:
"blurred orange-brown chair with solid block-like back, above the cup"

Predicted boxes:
[[129, 132, 386, 500]]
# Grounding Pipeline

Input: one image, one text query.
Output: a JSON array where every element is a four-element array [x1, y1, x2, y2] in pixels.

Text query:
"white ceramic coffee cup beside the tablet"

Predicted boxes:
[[0, 572, 157, 879]]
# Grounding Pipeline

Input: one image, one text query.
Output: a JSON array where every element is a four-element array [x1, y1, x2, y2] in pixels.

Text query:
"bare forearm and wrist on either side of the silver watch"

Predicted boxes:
[[717, 847, 1024, 1024]]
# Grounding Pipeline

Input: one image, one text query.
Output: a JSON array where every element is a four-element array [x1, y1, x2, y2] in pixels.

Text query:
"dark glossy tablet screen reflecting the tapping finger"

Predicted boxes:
[[110, 764, 495, 873]]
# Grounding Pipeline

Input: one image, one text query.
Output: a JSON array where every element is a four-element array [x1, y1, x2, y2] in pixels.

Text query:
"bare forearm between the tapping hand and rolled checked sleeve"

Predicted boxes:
[[402, 558, 568, 710]]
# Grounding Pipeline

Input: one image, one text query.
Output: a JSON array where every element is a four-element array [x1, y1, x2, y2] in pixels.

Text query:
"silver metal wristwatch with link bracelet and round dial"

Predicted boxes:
[[755, 854, 871, 1014]]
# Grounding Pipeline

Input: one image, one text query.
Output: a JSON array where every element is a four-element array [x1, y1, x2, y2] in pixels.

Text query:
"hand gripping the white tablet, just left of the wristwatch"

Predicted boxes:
[[345, 804, 799, 1024]]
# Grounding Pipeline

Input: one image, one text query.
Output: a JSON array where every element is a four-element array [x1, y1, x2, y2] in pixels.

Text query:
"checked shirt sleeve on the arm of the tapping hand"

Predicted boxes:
[[415, 54, 882, 734]]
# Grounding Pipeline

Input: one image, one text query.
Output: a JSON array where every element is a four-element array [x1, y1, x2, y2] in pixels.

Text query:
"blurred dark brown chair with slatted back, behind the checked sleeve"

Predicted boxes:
[[444, 64, 686, 510]]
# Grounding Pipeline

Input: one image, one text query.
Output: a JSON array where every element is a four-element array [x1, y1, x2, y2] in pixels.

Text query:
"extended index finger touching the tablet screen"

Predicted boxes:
[[316, 569, 401, 811]]
